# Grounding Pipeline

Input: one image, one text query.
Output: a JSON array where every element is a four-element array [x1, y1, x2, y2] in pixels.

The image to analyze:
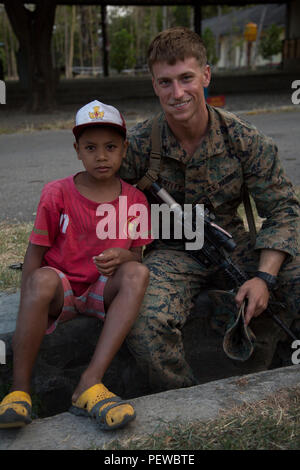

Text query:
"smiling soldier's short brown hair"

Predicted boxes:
[[147, 26, 207, 73]]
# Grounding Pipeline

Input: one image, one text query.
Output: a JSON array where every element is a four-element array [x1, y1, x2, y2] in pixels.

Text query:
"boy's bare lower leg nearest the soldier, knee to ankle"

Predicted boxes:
[[72, 261, 149, 402]]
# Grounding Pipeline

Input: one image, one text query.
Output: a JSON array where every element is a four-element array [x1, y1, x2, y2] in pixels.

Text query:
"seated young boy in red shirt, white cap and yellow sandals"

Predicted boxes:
[[0, 101, 152, 430]]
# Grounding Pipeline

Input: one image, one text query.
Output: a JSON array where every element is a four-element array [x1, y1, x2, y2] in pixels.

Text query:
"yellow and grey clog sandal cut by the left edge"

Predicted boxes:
[[0, 391, 32, 429]]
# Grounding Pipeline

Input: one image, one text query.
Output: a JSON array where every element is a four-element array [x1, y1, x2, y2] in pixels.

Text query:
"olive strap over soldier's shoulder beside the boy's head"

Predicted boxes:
[[136, 116, 161, 191]]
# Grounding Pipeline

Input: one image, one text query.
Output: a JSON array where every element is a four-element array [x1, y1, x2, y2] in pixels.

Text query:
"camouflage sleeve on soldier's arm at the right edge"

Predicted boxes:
[[244, 133, 300, 257]]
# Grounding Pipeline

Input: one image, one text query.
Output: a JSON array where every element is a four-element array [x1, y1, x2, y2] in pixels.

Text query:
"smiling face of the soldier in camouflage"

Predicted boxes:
[[152, 57, 210, 122]]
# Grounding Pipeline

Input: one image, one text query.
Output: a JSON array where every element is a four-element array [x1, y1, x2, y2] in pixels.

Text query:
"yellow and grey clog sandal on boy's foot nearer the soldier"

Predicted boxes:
[[69, 383, 136, 431]]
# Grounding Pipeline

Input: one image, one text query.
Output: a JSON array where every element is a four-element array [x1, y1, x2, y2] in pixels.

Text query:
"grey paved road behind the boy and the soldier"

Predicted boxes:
[[0, 111, 300, 221]]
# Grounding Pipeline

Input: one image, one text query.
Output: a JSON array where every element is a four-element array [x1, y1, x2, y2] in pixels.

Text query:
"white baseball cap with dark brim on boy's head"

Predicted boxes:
[[73, 100, 126, 139]]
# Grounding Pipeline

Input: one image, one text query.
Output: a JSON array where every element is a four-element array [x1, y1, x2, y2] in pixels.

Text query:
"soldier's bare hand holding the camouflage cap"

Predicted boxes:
[[235, 277, 270, 325]]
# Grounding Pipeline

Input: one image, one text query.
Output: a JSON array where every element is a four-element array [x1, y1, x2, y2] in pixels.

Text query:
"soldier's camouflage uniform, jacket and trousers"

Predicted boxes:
[[121, 106, 300, 390]]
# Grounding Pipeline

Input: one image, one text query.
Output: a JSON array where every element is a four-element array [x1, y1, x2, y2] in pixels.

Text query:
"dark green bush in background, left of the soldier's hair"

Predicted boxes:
[[110, 29, 135, 73]]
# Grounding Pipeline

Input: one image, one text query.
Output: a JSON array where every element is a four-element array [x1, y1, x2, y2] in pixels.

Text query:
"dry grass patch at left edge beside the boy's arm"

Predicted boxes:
[[0, 222, 32, 292]]
